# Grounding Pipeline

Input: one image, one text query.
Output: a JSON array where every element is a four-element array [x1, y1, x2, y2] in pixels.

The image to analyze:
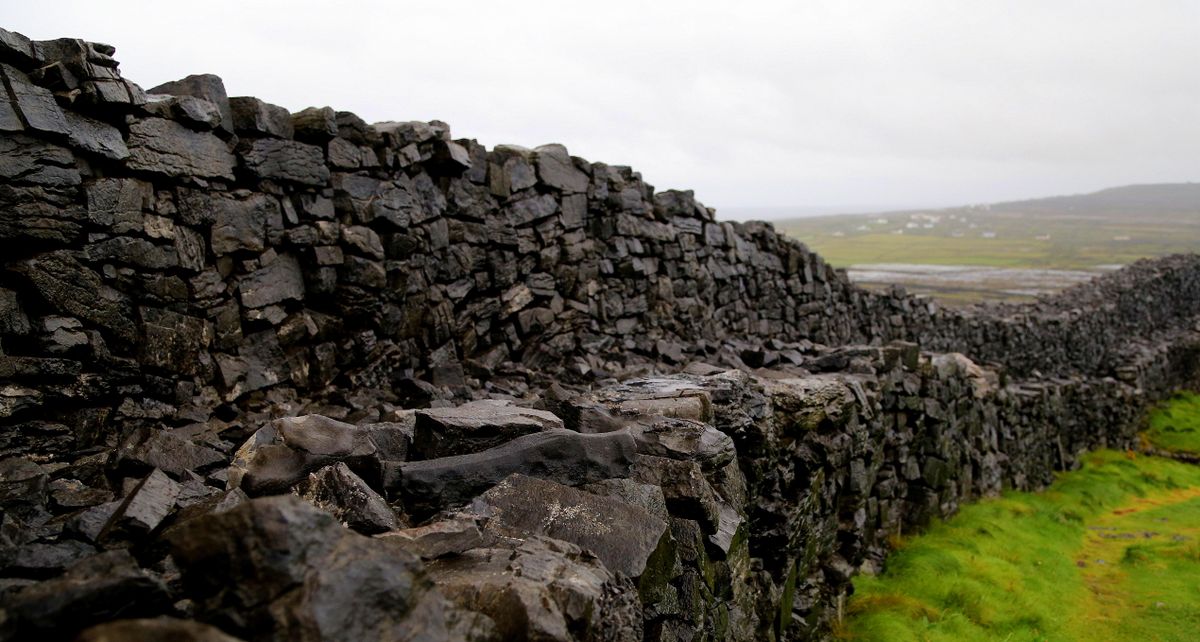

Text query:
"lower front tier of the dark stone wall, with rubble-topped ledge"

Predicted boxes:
[[7, 343, 1195, 641]]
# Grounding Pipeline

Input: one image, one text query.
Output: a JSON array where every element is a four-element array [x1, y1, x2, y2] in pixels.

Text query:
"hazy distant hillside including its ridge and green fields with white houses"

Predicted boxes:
[[775, 182, 1200, 291]]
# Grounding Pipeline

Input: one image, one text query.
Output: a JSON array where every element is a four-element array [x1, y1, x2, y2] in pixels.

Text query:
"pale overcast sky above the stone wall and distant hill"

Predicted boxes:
[[0, 0, 1200, 214]]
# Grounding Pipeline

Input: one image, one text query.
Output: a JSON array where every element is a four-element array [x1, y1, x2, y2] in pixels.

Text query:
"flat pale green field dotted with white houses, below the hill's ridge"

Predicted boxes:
[[776, 212, 1200, 269]]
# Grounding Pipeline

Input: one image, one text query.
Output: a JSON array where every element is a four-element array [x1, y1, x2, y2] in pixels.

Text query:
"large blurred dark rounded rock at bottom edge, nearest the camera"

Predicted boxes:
[[170, 496, 492, 642]]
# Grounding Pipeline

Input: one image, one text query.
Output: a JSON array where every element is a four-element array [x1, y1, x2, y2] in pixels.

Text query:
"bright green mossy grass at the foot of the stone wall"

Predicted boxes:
[[835, 395, 1200, 642]]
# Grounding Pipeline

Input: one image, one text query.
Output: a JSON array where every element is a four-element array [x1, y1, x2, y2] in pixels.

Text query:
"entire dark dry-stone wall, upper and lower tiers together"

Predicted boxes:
[[0, 30, 1200, 641]]
